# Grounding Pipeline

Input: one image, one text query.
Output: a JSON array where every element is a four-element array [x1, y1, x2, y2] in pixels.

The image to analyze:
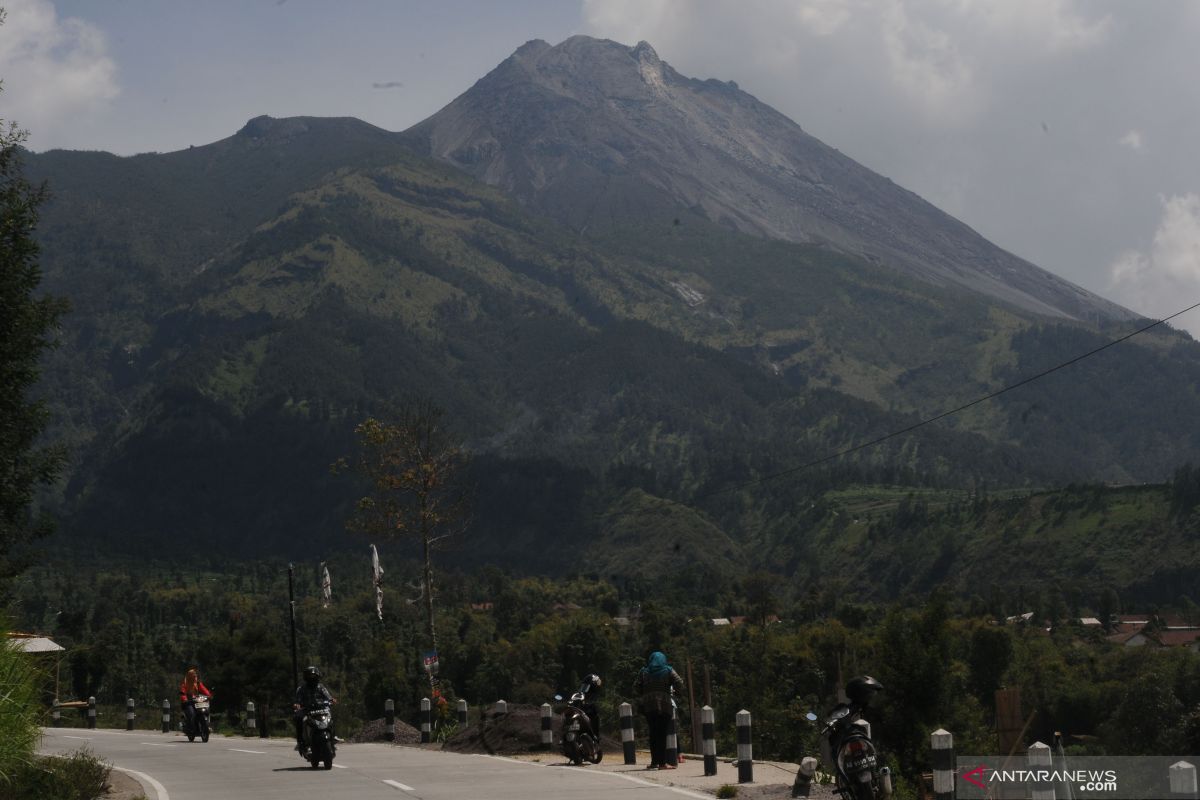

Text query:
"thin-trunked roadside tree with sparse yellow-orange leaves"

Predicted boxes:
[[335, 403, 469, 650]]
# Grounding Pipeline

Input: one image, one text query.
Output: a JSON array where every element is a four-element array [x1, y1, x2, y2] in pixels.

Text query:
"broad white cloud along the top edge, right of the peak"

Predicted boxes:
[[583, 0, 1114, 121]]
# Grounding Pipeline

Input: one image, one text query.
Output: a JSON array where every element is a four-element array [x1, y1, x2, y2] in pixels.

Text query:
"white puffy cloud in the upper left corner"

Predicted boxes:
[[0, 0, 120, 145]]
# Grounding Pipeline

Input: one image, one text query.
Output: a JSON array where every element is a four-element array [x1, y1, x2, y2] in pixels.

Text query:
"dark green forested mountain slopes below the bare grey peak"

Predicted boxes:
[[16, 40, 1200, 591]]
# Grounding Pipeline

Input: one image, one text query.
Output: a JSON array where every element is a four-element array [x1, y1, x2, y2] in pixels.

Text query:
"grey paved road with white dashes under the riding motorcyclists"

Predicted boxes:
[[41, 728, 712, 800]]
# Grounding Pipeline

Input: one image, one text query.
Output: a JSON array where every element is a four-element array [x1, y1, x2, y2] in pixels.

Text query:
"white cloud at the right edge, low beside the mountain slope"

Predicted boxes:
[[1110, 192, 1200, 336]]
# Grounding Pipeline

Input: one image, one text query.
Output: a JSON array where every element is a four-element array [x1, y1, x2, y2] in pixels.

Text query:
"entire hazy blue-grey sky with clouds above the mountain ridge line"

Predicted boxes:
[[0, 0, 1200, 336]]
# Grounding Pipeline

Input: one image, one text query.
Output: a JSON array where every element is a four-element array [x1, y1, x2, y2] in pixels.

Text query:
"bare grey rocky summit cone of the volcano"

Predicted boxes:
[[407, 36, 1134, 320]]
